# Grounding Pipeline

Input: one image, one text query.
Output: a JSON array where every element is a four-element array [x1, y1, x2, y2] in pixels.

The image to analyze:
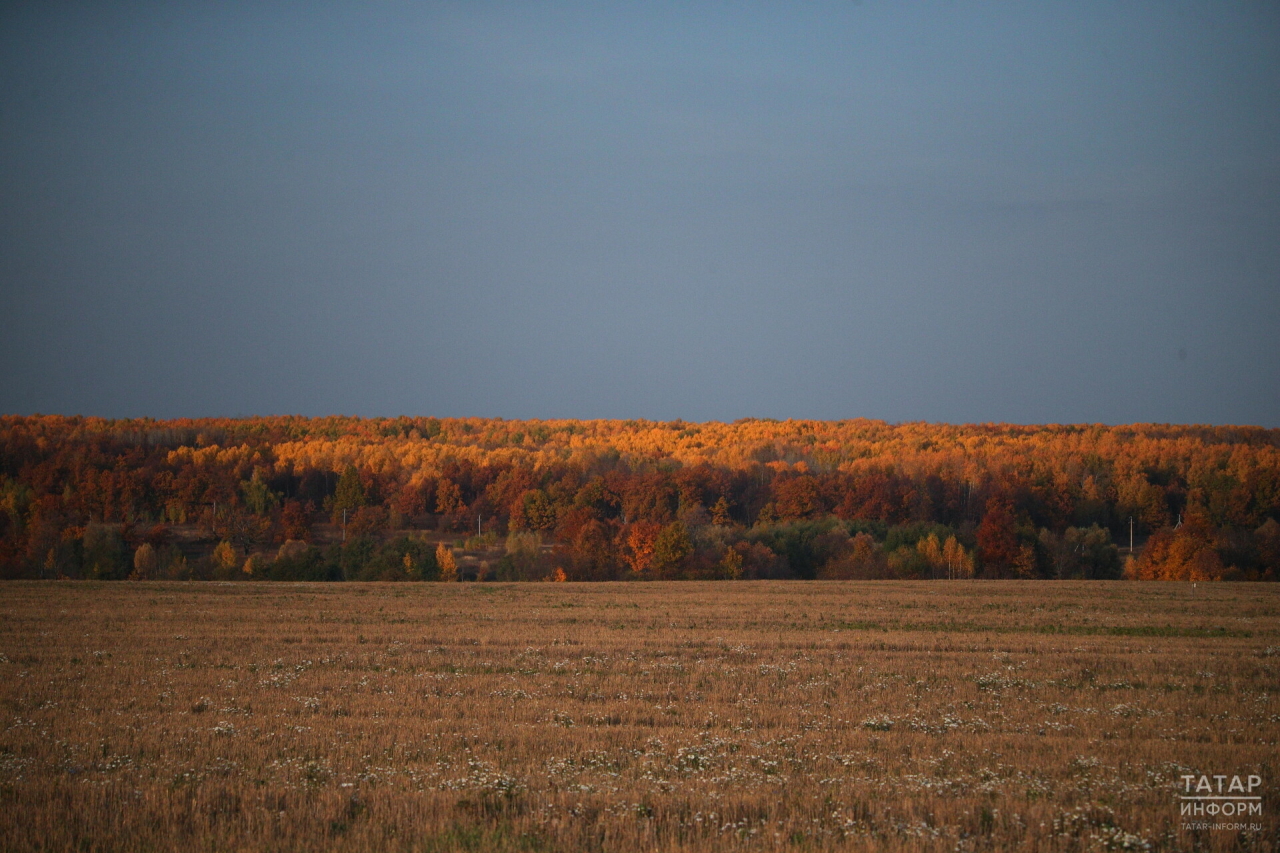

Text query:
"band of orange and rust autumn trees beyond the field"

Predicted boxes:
[[0, 416, 1280, 580]]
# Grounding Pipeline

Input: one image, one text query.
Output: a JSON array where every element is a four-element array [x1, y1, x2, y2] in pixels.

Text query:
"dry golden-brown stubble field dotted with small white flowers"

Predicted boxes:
[[0, 581, 1280, 850]]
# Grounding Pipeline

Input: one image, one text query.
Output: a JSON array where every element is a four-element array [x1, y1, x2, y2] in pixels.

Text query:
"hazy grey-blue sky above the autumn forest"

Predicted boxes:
[[0, 0, 1280, 428]]
